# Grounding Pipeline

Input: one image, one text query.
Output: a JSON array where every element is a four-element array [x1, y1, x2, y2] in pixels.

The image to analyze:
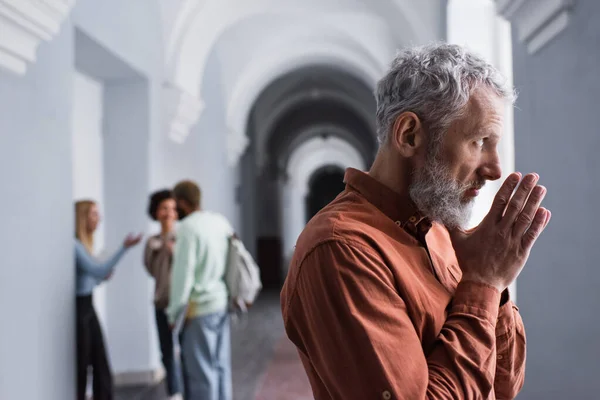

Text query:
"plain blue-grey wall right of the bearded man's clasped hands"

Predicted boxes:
[[513, 1, 600, 400]]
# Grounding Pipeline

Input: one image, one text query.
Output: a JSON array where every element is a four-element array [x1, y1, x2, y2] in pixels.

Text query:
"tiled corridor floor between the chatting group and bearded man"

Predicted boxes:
[[116, 292, 298, 400]]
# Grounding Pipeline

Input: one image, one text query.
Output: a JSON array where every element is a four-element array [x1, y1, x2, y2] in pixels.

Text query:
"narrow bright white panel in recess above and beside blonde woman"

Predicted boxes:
[[71, 71, 107, 331]]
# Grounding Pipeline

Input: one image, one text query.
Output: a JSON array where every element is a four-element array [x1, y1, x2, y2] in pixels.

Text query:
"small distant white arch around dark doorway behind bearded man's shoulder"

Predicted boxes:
[[281, 137, 365, 258]]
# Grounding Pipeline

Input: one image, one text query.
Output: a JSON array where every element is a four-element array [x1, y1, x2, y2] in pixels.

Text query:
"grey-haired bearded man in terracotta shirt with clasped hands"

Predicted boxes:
[[281, 44, 550, 400]]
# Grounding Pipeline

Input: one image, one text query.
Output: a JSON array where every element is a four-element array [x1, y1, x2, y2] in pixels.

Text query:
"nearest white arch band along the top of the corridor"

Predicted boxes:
[[166, 0, 428, 87]]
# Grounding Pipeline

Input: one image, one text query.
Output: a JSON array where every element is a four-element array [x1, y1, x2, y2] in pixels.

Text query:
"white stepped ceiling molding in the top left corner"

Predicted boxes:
[[0, 0, 75, 75]]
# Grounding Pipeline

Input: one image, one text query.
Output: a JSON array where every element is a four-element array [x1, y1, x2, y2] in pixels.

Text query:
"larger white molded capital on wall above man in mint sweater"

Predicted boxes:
[[163, 82, 204, 143]]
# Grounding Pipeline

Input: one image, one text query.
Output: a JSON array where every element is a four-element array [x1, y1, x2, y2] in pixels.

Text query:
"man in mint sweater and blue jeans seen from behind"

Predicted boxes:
[[167, 181, 233, 400]]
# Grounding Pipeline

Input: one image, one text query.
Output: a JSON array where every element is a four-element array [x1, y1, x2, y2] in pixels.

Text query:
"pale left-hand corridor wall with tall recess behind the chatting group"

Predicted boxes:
[[0, 0, 237, 394]]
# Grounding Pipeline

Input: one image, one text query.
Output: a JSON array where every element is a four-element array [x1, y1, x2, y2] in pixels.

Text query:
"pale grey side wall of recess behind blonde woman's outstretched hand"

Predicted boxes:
[[104, 78, 158, 383]]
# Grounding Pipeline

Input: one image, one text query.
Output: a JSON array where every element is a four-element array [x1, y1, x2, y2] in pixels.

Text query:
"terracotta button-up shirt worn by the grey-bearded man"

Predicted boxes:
[[281, 169, 525, 400]]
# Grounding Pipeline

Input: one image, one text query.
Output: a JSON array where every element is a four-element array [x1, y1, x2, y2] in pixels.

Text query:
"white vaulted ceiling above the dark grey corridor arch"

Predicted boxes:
[[162, 0, 445, 162]]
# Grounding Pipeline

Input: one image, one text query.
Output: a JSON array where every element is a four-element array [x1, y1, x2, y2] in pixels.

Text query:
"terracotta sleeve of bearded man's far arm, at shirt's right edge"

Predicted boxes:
[[494, 301, 526, 400]]
